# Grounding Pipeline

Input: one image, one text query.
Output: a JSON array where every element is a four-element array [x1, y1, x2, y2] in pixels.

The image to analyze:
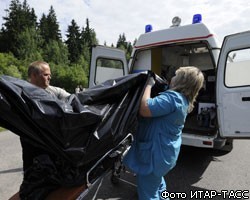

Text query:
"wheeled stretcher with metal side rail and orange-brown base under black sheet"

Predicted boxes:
[[9, 134, 133, 200]]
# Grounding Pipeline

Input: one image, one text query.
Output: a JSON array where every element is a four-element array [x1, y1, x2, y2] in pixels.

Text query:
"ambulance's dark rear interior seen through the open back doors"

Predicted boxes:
[[132, 41, 217, 136]]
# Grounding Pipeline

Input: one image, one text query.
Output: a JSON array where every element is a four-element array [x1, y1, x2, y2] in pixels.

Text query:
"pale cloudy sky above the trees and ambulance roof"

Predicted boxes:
[[0, 0, 250, 45]]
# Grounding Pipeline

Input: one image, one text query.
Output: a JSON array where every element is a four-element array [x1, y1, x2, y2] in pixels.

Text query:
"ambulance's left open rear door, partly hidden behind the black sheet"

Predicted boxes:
[[89, 46, 128, 87]]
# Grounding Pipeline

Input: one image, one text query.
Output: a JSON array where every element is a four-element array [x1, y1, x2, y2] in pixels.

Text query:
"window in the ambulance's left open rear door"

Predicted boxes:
[[95, 58, 124, 84]]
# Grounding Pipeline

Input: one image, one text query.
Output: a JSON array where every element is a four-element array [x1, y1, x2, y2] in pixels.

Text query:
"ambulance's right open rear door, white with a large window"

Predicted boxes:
[[216, 31, 250, 138]]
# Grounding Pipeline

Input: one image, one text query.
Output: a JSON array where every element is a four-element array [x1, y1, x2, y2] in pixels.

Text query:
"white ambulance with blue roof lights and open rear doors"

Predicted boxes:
[[89, 15, 250, 150]]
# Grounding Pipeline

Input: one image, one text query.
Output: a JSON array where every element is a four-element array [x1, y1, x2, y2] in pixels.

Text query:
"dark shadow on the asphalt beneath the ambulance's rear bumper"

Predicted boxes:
[[165, 146, 232, 200]]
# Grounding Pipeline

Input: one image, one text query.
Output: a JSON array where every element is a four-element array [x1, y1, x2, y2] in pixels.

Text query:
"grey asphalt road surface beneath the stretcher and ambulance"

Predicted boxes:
[[0, 131, 250, 200]]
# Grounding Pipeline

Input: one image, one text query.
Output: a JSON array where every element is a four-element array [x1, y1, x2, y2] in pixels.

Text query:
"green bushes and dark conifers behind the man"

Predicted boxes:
[[0, 0, 135, 93]]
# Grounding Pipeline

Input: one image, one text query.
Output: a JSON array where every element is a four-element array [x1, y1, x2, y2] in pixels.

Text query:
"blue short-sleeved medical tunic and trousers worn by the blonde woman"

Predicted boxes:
[[123, 90, 188, 200]]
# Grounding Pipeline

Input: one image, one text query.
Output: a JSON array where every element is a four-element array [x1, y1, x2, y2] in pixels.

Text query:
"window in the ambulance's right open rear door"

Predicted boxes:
[[225, 49, 250, 87]]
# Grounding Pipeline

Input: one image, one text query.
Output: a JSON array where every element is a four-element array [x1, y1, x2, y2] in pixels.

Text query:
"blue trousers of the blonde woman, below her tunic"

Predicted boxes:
[[136, 173, 167, 200]]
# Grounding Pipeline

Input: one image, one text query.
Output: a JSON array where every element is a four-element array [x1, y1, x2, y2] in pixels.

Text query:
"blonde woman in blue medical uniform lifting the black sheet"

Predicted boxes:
[[123, 66, 204, 200]]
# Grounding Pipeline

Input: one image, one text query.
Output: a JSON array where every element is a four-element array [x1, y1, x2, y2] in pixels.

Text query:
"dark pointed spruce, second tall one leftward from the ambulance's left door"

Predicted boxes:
[[65, 20, 82, 63]]
